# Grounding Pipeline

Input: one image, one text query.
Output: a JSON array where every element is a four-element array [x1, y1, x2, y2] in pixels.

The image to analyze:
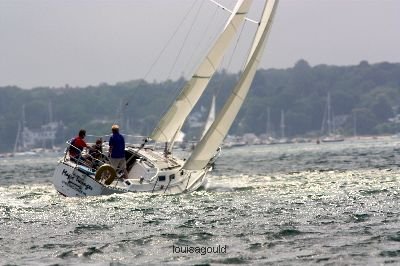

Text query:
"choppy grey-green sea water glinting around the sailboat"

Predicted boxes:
[[0, 138, 400, 265]]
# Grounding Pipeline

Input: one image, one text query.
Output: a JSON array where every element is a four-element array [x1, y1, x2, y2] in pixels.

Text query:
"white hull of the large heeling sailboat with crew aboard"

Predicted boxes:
[[53, 149, 211, 197]]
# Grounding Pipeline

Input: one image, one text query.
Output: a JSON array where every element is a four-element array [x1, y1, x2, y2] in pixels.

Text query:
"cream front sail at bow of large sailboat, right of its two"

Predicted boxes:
[[183, 0, 278, 170]]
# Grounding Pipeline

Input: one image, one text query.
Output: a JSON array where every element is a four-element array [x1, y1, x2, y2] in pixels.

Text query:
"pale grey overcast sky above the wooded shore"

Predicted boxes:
[[0, 0, 400, 88]]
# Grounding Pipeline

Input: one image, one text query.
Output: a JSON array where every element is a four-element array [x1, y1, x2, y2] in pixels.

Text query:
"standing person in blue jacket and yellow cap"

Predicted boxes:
[[108, 125, 128, 178]]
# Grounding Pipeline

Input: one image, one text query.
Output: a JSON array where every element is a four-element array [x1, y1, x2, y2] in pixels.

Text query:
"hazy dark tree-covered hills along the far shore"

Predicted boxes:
[[0, 60, 400, 152]]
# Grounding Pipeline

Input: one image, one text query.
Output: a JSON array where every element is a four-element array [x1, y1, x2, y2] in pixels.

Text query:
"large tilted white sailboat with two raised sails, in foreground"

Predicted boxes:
[[53, 0, 279, 197]]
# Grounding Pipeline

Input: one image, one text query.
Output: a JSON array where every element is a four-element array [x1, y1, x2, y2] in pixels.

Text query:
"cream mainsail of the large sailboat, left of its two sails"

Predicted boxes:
[[150, 0, 252, 142]]
